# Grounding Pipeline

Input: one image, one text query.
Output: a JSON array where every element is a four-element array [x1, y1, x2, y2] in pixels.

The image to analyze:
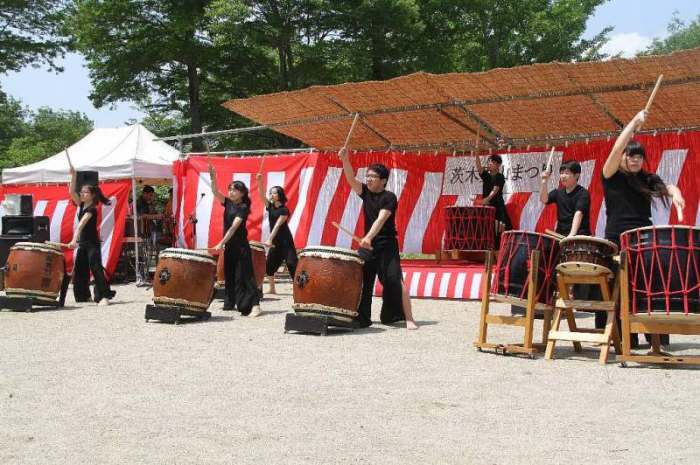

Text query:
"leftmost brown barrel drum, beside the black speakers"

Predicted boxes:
[[4, 242, 66, 303]]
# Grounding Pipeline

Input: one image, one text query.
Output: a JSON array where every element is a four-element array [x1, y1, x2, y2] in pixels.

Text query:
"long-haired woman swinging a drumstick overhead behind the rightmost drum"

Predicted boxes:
[[596, 110, 685, 346]]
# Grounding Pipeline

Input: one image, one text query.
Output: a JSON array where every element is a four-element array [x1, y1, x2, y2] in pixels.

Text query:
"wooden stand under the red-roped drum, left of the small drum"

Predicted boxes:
[[474, 250, 554, 358]]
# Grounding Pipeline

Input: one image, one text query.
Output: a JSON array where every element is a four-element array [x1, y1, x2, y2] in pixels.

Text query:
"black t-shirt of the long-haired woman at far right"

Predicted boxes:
[[603, 171, 662, 242]]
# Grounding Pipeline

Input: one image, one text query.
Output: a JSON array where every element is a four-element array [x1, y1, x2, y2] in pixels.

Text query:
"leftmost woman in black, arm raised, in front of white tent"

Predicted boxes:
[[68, 165, 116, 306]]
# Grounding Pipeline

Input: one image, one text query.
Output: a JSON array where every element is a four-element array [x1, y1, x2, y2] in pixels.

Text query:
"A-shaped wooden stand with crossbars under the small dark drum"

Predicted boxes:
[[544, 271, 622, 365]]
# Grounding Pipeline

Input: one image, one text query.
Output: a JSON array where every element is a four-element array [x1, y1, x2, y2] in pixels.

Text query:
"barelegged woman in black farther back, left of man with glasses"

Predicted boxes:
[[256, 173, 297, 294]]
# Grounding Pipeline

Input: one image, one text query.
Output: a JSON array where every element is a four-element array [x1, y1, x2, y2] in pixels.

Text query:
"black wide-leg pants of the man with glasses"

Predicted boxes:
[[357, 239, 406, 326]]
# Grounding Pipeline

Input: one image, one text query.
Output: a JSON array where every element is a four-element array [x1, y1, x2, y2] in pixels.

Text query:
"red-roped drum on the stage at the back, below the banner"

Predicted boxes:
[[444, 206, 496, 250]]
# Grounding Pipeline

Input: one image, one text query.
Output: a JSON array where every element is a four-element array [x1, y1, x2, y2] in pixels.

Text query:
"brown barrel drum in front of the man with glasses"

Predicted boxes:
[[293, 246, 364, 322]]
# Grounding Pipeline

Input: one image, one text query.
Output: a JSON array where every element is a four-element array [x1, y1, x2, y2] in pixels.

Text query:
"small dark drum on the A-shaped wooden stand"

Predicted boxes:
[[557, 236, 617, 276]]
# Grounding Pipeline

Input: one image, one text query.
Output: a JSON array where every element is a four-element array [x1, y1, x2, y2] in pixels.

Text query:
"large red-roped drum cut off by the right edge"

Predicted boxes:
[[620, 226, 700, 313]]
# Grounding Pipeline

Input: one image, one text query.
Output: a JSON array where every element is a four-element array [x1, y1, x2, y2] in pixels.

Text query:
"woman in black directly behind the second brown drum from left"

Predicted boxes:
[[209, 164, 261, 317]]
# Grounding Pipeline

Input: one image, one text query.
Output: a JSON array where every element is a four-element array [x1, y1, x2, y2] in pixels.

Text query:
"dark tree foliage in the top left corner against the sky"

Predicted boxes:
[[0, 0, 68, 74]]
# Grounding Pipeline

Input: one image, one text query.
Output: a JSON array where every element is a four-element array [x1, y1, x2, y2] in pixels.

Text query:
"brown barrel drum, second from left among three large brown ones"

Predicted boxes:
[[153, 248, 216, 311]]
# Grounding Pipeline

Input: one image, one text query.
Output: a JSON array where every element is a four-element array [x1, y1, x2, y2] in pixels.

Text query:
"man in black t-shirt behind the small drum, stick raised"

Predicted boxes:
[[540, 160, 591, 237]]
